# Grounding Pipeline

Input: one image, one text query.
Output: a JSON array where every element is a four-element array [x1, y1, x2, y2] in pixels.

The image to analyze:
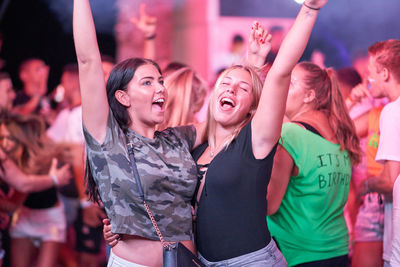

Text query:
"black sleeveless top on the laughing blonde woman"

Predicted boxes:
[[193, 123, 276, 261]]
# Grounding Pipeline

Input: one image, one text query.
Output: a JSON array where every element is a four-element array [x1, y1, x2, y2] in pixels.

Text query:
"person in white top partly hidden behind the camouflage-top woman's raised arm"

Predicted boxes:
[[47, 64, 105, 267]]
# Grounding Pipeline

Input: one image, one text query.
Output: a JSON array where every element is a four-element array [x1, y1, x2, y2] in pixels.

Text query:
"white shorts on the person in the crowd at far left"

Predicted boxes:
[[10, 202, 67, 246]]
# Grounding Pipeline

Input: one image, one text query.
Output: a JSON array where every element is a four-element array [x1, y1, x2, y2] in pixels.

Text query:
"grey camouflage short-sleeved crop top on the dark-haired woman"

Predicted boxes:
[[83, 111, 197, 241]]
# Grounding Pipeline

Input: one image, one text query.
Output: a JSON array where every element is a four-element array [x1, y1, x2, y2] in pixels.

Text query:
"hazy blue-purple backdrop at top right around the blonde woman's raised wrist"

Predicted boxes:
[[220, 0, 400, 67]]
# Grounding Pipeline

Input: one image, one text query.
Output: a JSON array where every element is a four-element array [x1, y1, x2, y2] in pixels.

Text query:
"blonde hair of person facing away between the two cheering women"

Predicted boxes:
[[157, 67, 207, 130]]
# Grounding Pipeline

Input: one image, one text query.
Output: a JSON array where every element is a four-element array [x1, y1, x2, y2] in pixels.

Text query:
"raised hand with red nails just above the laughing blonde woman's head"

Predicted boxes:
[[248, 21, 272, 68]]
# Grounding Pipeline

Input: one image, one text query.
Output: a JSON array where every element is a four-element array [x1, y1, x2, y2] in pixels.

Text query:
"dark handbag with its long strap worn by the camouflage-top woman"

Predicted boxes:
[[128, 142, 205, 267]]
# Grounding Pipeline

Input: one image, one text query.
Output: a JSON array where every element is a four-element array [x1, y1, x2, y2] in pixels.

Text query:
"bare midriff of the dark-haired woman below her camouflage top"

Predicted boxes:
[[112, 235, 197, 267]]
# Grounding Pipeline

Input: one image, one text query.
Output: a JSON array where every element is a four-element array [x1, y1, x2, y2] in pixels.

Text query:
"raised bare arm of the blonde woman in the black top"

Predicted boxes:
[[252, 0, 328, 158]]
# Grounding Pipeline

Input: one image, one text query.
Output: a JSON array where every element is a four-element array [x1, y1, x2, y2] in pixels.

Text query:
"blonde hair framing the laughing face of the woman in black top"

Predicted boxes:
[[207, 65, 263, 149]]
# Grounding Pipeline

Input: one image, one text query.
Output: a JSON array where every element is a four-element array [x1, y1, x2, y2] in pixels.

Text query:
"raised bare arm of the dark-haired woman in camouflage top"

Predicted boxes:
[[73, 0, 109, 143]]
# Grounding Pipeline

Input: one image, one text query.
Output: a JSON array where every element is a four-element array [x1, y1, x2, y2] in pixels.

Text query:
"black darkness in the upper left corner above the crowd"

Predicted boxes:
[[0, 0, 115, 90]]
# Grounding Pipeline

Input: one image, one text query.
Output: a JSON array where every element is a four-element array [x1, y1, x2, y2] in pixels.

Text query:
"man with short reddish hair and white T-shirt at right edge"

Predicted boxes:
[[352, 39, 400, 266]]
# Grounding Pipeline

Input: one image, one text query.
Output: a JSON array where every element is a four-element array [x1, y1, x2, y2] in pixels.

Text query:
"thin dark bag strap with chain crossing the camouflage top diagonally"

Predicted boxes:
[[126, 137, 170, 248]]
